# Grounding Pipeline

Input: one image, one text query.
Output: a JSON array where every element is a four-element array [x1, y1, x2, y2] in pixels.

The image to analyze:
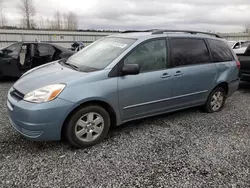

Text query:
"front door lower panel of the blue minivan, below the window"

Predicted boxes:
[[118, 69, 172, 121]]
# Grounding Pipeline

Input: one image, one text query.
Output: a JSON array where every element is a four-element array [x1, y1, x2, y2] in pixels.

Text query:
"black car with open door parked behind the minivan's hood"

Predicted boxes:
[[0, 42, 74, 77]]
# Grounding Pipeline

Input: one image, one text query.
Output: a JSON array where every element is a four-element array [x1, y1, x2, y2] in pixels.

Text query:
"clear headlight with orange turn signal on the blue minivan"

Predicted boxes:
[[24, 84, 66, 103]]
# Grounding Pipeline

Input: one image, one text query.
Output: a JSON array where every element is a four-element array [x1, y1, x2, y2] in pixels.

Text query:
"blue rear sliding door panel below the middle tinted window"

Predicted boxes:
[[172, 63, 217, 108]]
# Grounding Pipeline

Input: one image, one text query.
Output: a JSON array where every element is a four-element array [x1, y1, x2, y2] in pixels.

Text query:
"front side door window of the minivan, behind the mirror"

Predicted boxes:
[[124, 39, 167, 72]]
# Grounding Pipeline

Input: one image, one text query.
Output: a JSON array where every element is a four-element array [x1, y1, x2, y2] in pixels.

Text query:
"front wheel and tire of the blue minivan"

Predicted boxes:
[[64, 105, 110, 148]]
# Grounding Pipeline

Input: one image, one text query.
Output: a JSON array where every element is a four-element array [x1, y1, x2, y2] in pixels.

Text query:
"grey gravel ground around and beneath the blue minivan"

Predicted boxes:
[[0, 81, 250, 188]]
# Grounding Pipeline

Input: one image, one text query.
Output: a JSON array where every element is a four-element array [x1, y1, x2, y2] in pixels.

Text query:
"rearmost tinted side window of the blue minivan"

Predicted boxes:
[[208, 39, 233, 62]]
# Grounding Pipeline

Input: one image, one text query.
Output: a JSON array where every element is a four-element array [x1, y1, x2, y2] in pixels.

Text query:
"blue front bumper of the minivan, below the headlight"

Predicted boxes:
[[7, 88, 73, 141]]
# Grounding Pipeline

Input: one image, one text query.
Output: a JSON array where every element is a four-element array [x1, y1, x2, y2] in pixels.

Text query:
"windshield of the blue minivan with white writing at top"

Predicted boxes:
[[66, 37, 135, 71]]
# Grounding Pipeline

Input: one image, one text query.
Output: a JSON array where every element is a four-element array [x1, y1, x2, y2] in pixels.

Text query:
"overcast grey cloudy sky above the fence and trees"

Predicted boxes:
[[4, 0, 250, 32]]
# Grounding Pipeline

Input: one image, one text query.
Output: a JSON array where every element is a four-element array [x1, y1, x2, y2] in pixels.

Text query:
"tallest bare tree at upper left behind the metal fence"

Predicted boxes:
[[19, 0, 35, 29]]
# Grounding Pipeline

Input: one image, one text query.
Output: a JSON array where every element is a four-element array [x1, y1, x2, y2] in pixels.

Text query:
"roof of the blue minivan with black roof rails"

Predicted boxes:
[[108, 31, 225, 40]]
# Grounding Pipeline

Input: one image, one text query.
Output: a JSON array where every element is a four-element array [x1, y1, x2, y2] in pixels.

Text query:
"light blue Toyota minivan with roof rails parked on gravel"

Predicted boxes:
[[7, 30, 240, 148]]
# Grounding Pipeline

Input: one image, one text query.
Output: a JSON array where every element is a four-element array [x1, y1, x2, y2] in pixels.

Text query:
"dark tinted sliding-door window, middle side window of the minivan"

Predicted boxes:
[[171, 38, 211, 66]]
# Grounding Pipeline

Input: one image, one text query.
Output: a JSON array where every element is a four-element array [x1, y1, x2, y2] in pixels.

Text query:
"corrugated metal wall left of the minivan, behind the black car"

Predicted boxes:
[[0, 29, 114, 48]]
